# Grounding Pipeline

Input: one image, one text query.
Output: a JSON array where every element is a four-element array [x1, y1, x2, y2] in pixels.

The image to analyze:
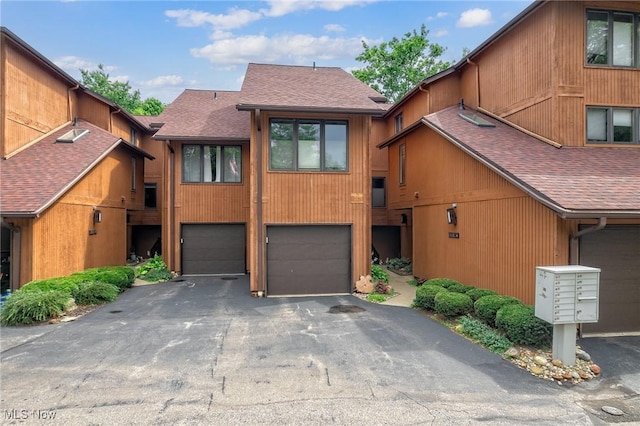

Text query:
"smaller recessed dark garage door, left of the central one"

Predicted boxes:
[[182, 224, 246, 275]]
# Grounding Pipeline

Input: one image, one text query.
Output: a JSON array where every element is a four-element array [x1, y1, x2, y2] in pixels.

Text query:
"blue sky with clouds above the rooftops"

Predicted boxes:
[[0, 0, 532, 103]]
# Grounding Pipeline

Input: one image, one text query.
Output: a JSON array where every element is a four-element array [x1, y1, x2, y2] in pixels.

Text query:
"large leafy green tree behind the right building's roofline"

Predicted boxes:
[[353, 25, 451, 102]]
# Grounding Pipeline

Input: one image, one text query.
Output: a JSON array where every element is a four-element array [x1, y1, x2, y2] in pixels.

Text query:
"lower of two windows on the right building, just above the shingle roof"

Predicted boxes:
[[587, 106, 640, 145]]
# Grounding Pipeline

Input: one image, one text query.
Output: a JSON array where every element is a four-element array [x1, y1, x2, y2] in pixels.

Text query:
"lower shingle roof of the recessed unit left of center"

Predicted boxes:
[[154, 89, 251, 141]]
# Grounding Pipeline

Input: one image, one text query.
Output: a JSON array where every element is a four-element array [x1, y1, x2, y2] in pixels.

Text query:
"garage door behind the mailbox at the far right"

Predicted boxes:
[[580, 226, 640, 335]]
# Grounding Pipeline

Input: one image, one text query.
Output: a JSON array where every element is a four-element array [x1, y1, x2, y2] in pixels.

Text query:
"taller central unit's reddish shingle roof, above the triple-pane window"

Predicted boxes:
[[238, 63, 389, 115]]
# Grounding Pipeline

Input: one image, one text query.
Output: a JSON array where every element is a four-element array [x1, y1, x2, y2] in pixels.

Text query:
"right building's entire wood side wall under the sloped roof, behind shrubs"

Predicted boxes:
[[389, 128, 568, 303]]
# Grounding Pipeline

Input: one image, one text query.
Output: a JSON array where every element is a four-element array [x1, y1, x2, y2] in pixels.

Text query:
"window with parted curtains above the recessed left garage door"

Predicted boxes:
[[182, 145, 242, 183]]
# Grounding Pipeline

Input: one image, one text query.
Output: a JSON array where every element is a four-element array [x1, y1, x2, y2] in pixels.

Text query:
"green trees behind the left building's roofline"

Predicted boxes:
[[80, 64, 165, 115]]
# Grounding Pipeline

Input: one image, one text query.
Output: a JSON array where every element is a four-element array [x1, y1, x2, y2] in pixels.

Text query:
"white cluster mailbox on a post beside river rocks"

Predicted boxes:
[[535, 265, 600, 365]]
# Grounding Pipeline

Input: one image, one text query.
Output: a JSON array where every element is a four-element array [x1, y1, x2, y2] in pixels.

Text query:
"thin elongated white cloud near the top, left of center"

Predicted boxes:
[[164, 8, 262, 30]]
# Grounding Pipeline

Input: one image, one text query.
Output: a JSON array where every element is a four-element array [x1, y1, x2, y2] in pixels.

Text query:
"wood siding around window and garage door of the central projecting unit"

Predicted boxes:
[[249, 113, 371, 291]]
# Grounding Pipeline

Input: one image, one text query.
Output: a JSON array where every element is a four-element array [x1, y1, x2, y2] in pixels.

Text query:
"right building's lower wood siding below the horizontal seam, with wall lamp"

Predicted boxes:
[[413, 196, 559, 304]]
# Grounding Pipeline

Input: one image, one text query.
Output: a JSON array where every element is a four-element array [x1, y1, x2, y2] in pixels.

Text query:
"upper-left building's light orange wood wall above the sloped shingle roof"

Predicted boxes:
[[0, 37, 74, 155]]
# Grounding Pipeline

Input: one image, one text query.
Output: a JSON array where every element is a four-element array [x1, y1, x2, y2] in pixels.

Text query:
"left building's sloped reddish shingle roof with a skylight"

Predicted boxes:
[[0, 120, 153, 216]]
